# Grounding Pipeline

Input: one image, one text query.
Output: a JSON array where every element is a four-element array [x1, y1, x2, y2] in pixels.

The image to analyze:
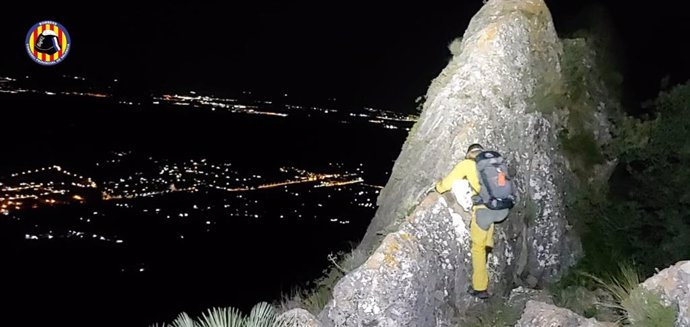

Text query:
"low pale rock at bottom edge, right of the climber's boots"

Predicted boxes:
[[515, 301, 616, 327]]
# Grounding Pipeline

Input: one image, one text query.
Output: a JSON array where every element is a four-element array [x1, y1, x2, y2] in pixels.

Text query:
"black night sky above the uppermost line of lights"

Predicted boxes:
[[0, 0, 690, 111]]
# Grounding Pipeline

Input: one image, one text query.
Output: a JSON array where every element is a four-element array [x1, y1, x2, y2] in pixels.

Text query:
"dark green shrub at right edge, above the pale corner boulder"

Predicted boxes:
[[583, 83, 690, 274]]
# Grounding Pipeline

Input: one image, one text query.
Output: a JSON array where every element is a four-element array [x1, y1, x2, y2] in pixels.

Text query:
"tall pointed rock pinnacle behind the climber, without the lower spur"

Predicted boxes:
[[360, 0, 580, 292]]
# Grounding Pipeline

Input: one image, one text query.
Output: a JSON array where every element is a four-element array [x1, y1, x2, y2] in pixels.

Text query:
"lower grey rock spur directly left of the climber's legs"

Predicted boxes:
[[319, 194, 470, 327]]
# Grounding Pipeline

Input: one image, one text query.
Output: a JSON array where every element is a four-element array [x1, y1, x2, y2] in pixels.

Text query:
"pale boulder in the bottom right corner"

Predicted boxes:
[[642, 261, 690, 327]]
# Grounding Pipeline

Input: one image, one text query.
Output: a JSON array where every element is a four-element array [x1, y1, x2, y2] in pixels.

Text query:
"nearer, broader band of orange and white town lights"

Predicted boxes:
[[0, 152, 382, 244]]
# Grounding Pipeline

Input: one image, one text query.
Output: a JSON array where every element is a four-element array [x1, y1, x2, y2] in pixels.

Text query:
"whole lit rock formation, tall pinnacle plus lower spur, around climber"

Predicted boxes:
[[319, 0, 608, 326]]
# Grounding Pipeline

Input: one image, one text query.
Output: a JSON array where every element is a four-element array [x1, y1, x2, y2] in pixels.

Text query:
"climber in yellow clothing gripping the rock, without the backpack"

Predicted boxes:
[[435, 143, 512, 299]]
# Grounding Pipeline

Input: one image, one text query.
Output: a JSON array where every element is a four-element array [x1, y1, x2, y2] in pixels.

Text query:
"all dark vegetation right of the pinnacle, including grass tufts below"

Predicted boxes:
[[552, 5, 690, 326]]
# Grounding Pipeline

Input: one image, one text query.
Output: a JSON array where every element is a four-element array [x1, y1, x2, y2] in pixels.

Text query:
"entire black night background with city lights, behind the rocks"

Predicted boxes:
[[0, 0, 690, 326]]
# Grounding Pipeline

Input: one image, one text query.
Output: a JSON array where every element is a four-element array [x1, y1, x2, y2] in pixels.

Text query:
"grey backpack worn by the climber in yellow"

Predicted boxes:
[[475, 151, 515, 210]]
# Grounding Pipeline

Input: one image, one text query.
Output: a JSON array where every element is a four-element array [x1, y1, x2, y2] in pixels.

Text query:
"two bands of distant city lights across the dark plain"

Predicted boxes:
[[0, 75, 396, 243]]
